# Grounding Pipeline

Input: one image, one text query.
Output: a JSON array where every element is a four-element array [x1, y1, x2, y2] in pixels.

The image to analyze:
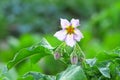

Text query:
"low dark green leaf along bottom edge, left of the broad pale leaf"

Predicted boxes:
[[23, 72, 55, 80]]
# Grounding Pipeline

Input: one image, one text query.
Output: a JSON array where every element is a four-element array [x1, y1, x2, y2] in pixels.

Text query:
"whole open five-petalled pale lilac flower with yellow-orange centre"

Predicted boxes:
[[54, 19, 83, 47]]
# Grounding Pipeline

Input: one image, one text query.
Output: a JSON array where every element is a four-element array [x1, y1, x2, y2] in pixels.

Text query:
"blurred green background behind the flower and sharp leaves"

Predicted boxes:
[[0, 0, 120, 79]]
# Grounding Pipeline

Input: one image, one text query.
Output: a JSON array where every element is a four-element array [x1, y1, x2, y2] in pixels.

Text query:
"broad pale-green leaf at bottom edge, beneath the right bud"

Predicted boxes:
[[56, 65, 87, 80]]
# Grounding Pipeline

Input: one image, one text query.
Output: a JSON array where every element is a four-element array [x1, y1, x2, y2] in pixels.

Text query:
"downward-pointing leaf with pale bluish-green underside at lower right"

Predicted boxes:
[[97, 61, 111, 78]]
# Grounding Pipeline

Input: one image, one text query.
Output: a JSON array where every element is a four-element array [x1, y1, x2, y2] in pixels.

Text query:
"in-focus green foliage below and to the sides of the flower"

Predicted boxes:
[[3, 39, 120, 80]]
